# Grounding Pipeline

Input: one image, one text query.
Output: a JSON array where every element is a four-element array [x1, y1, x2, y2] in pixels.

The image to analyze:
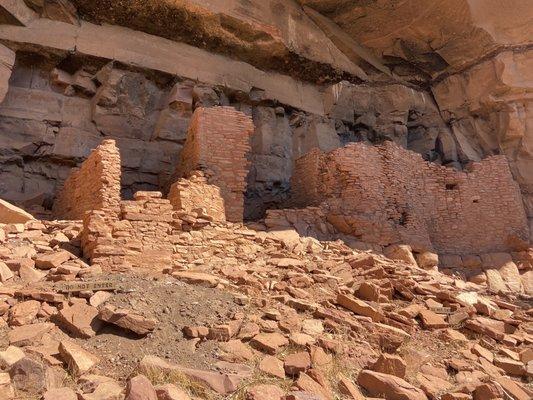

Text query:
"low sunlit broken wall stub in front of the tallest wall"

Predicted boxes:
[[168, 171, 226, 222]]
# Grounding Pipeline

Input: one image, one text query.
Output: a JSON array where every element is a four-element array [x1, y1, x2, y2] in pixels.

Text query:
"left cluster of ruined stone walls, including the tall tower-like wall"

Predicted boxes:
[[54, 107, 253, 269]]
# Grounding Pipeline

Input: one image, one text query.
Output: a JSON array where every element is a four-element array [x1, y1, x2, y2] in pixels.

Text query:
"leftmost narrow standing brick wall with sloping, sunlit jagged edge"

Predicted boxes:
[[53, 140, 120, 219]]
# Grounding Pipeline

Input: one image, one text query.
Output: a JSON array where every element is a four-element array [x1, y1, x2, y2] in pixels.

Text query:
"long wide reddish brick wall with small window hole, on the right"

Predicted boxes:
[[292, 142, 529, 254]]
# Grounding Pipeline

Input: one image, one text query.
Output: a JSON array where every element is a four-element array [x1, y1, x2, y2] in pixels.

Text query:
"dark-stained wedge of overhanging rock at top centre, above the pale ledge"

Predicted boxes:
[[68, 0, 364, 81]]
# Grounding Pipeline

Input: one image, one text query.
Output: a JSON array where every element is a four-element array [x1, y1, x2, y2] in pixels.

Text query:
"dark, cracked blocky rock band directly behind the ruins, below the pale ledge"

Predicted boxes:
[[0, 54, 448, 219]]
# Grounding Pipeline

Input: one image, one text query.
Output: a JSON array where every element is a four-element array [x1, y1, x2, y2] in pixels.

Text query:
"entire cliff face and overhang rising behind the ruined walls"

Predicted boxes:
[[0, 0, 533, 231]]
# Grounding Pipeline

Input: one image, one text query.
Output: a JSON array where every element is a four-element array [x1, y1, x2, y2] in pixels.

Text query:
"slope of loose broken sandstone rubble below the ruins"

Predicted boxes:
[[0, 208, 533, 400]]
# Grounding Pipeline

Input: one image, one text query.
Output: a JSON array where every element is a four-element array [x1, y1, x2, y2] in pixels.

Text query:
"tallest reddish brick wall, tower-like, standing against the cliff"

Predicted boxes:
[[171, 107, 254, 222]]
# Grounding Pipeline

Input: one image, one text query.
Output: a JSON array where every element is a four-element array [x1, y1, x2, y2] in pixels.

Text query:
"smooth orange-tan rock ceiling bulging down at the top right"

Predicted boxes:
[[299, 0, 533, 77]]
